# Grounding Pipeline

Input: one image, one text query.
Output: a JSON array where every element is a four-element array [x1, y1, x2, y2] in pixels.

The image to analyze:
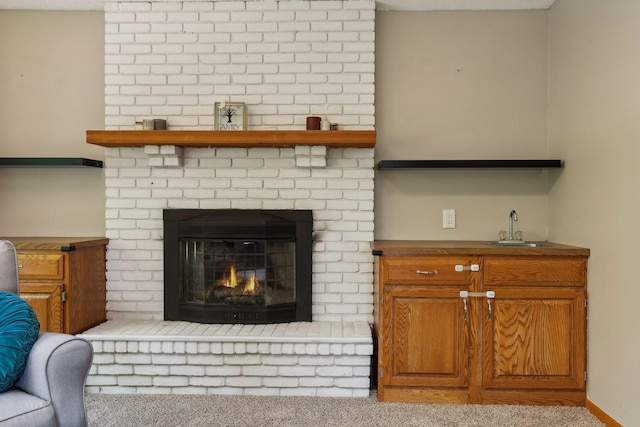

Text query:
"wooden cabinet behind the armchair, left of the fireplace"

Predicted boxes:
[[2, 237, 109, 334]]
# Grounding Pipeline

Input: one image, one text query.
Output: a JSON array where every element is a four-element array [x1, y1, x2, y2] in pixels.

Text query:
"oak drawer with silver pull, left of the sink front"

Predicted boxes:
[[381, 256, 477, 285]]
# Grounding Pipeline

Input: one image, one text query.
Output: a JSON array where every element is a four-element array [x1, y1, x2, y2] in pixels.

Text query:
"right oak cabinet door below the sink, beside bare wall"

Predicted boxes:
[[481, 288, 585, 389]]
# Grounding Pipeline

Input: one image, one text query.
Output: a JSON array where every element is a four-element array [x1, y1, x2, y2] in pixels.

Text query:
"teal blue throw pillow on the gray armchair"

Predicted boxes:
[[0, 292, 40, 392]]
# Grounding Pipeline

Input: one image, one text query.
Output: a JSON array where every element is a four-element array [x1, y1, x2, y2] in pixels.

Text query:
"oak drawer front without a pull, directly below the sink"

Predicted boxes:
[[482, 256, 587, 286]]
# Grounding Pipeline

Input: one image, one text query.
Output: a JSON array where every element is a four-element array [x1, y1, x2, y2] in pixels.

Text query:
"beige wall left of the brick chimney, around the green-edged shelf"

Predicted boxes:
[[0, 11, 104, 236]]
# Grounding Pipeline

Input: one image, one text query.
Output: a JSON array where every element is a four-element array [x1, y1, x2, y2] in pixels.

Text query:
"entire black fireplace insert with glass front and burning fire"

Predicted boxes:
[[163, 209, 313, 323]]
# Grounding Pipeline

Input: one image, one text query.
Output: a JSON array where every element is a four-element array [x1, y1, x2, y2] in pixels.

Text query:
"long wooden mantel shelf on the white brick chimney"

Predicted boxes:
[[87, 130, 376, 148]]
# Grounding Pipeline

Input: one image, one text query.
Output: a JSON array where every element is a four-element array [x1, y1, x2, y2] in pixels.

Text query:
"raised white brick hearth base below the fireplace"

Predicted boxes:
[[79, 320, 373, 397]]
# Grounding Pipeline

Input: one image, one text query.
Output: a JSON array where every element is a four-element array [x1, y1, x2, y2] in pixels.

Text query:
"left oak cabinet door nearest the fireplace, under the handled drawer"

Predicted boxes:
[[383, 286, 468, 387]]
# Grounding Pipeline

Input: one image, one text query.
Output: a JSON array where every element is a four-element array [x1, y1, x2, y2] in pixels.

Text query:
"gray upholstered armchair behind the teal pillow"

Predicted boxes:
[[0, 240, 93, 427]]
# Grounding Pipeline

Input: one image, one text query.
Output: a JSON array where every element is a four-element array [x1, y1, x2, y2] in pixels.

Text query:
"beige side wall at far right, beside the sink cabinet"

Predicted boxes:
[[549, 0, 640, 426]]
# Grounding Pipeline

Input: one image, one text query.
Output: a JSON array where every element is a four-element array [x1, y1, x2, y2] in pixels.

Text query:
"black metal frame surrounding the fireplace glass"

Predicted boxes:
[[163, 209, 313, 324]]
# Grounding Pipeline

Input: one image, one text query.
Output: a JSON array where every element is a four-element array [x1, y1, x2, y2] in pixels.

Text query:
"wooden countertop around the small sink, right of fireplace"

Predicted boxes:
[[371, 240, 590, 256]]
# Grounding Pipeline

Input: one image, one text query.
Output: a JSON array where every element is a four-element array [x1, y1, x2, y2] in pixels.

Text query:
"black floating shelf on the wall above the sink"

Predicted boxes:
[[378, 160, 562, 170]]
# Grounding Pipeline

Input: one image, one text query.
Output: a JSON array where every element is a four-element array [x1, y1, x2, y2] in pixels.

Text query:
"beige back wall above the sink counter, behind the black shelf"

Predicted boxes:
[[375, 11, 555, 240]]
